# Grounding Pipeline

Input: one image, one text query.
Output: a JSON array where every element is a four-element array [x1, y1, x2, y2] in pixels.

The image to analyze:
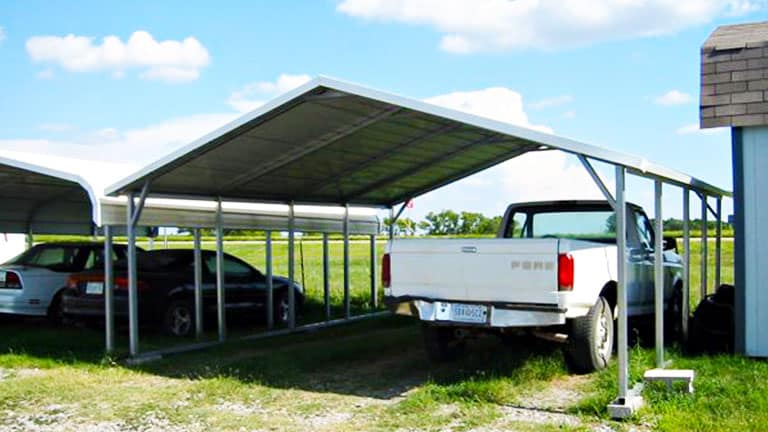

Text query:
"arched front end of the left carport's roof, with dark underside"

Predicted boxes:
[[0, 157, 98, 234]]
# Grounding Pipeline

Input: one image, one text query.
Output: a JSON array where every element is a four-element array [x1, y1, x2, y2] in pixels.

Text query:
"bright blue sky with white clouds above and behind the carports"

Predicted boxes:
[[0, 0, 766, 221]]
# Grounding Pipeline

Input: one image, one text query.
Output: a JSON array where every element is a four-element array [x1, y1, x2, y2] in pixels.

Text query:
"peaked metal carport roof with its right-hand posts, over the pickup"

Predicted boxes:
[[107, 77, 729, 415]]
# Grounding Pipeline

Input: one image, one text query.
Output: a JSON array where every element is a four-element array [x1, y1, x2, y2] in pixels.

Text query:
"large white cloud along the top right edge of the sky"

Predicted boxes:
[[337, 0, 764, 54]]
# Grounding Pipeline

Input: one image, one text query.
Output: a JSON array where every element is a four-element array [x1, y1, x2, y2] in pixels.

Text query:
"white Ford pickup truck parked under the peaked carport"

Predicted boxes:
[[382, 201, 682, 372]]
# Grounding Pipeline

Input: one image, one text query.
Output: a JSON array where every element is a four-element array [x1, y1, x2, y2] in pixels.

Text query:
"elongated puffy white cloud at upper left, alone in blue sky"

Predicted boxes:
[[26, 31, 210, 82]]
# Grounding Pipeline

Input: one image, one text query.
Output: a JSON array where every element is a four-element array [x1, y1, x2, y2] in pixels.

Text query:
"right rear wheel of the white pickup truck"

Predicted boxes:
[[565, 297, 613, 373]]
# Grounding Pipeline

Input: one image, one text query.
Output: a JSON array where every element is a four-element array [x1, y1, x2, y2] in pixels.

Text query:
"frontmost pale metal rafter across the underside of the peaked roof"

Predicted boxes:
[[220, 107, 401, 191]]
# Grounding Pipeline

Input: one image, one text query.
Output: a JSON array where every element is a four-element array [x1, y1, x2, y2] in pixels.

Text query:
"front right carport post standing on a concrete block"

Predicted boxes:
[[615, 166, 629, 400]]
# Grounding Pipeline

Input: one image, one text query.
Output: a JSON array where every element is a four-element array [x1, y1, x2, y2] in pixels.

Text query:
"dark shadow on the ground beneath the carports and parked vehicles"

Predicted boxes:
[[0, 310, 563, 399]]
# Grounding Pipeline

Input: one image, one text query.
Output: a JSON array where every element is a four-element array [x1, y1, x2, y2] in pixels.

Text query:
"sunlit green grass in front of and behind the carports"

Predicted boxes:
[[0, 238, 768, 431]]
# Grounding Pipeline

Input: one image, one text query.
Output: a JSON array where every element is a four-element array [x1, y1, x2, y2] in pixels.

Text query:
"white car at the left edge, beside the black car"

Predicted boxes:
[[0, 242, 126, 321]]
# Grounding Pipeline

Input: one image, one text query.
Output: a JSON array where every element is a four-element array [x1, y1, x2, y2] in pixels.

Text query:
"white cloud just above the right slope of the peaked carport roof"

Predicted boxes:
[[424, 87, 552, 133]]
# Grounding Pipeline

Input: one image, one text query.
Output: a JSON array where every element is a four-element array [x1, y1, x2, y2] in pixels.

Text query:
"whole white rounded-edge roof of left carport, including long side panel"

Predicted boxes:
[[0, 156, 379, 235]]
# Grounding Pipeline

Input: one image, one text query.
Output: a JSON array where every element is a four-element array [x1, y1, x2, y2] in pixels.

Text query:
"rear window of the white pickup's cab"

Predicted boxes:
[[506, 210, 616, 241]]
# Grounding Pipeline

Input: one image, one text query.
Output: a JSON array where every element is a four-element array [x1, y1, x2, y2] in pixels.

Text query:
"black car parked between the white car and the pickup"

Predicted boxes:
[[62, 249, 304, 336]]
